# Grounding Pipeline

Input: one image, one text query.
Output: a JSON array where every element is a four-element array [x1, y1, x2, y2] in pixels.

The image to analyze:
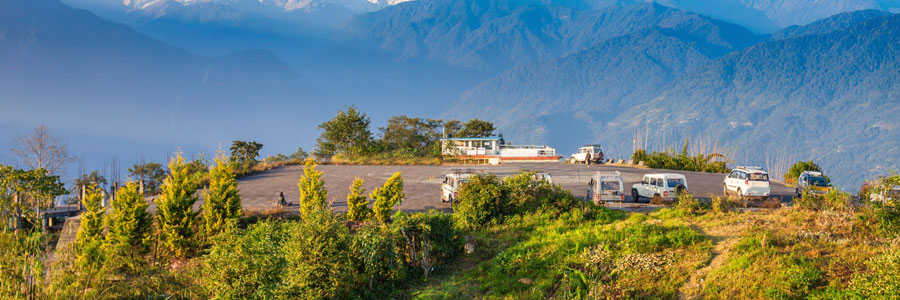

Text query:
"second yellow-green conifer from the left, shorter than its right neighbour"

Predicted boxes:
[[106, 182, 153, 266]]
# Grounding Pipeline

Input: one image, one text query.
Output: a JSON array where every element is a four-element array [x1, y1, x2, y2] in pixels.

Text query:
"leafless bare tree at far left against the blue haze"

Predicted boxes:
[[10, 124, 75, 174]]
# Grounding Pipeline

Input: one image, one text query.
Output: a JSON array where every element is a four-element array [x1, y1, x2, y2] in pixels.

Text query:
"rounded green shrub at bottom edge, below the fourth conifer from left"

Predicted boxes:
[[200, 221, 291, 299]]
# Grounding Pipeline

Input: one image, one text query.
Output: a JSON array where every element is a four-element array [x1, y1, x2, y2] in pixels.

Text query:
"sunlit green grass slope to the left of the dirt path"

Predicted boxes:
[[412, 209, 711, 299]]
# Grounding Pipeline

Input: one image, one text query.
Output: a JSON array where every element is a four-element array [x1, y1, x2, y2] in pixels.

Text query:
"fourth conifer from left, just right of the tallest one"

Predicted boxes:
[[203, 153, 241, 237]]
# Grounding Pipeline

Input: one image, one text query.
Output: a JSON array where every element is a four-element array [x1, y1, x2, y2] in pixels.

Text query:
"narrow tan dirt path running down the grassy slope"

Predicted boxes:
[[678, 217, 748, 299]]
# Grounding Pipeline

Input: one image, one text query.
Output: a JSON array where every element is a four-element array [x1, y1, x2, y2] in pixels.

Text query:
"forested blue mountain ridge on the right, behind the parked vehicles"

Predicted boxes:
[[451, 11, 900, 189]]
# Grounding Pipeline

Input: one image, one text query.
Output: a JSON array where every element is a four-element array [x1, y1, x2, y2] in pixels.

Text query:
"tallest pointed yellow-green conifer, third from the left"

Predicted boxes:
[[155, 153, 198, 258]]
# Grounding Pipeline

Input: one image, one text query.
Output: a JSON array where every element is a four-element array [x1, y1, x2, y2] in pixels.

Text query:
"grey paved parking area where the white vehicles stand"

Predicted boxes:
[[239, 163, 793, 211]]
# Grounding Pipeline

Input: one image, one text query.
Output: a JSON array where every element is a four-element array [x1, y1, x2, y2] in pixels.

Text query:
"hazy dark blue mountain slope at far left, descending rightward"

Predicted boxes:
[[0, 0, 330, 158]]
